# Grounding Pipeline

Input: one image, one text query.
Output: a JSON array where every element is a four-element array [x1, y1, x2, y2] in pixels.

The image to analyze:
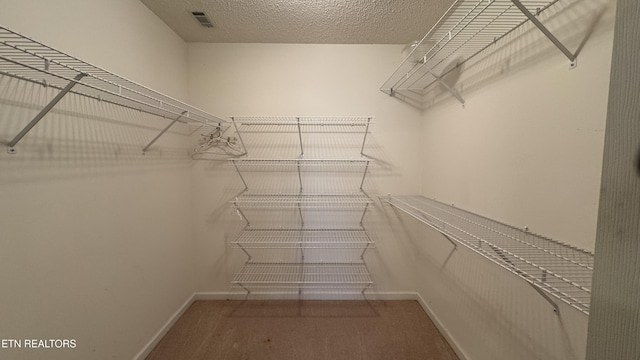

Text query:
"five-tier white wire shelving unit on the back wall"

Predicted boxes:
[[228, 117, 374, 295]]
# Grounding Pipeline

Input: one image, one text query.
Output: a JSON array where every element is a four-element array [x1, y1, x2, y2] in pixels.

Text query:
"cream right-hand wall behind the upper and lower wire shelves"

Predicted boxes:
[[394, 1, 613, 360]]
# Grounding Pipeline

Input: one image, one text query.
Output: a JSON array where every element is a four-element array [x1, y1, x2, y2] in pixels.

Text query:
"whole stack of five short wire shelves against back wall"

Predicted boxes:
[[229, 116, 373, 294]]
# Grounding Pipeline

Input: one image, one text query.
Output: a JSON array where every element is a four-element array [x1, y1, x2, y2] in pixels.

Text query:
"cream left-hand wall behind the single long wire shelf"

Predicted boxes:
[[0, 0, 194, 359]]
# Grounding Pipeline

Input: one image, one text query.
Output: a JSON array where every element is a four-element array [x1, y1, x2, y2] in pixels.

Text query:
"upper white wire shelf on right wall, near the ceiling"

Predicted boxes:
[[380, 0, 575, 103]]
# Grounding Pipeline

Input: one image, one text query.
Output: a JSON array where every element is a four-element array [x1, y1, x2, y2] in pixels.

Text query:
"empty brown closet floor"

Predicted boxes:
[[147, 300, 458, 360]]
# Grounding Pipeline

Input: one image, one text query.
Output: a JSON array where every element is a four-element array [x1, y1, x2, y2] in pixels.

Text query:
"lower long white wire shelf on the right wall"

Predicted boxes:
[[383, 196, 594, 315]]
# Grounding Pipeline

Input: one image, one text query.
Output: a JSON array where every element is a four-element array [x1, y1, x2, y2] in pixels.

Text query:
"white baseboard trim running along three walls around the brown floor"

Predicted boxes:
[[133, 291, 469, 360]]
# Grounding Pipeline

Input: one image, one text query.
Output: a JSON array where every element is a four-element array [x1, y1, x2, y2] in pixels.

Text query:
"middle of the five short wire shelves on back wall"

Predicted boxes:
[[230, 194, 373, 209]]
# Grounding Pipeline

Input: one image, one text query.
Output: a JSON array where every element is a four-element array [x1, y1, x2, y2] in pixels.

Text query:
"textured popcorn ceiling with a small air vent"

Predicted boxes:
[[141, 0, 454, 44]]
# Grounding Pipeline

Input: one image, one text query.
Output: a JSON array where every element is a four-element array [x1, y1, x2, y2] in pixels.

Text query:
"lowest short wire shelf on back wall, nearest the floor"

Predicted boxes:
[[231, 262, 373, 290]]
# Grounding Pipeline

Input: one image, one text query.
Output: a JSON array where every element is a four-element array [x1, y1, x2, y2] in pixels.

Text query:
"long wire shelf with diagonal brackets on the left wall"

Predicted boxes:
[[0, 26, 228, 154]]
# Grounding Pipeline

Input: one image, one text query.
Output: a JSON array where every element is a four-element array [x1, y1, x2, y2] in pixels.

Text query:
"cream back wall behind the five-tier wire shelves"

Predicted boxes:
[[189, 44, 421, 298]]
